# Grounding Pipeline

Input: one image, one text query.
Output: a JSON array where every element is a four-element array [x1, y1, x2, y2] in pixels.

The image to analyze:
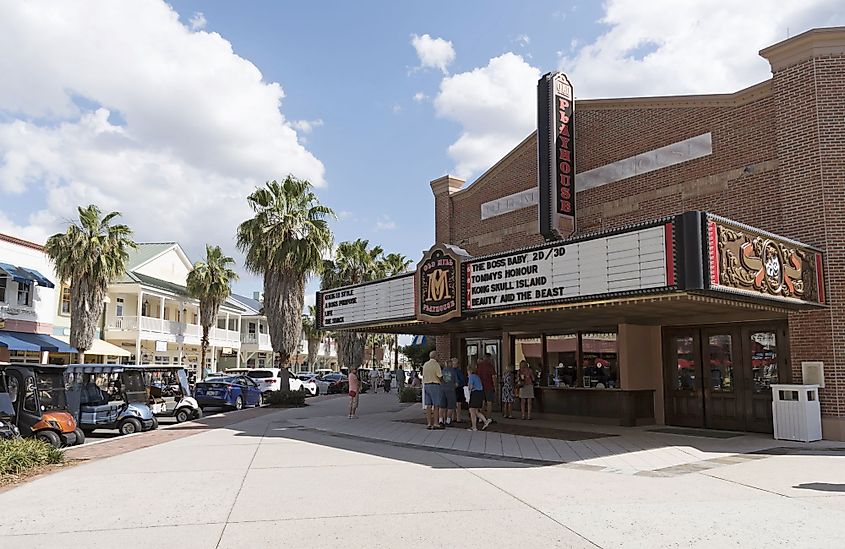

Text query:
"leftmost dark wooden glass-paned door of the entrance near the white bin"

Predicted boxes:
[[663, 328, 704, 427]]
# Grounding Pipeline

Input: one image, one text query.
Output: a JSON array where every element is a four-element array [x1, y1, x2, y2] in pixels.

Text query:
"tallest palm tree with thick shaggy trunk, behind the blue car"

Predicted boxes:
[[238, 176, 334, 364]]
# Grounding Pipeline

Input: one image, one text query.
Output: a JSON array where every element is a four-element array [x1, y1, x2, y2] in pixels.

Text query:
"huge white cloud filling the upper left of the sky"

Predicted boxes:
[[0, 0, 324, 262]]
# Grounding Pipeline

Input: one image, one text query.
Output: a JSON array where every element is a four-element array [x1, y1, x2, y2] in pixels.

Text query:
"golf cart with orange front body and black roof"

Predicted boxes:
[[0, 364, 85, 448]]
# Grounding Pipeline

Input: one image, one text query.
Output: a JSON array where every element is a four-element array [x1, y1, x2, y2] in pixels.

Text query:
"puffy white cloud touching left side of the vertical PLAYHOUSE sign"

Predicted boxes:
[[434, 52, 540, 178]]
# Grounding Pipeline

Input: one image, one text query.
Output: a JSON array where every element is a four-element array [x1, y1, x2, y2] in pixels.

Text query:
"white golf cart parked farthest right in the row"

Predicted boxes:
[[143, 365, 202, 423]]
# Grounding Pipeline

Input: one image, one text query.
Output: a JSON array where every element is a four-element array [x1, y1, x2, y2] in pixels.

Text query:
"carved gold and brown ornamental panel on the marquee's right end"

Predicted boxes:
[[707, 216, 825, 303]]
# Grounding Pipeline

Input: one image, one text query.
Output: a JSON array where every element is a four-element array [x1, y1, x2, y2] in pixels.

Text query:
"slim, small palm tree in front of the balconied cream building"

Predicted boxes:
[[188, 244, 238, 380]]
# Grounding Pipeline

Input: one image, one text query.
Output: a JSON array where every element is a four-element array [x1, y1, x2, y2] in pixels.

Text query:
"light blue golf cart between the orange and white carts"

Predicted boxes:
[[66, 364, 158, 435]]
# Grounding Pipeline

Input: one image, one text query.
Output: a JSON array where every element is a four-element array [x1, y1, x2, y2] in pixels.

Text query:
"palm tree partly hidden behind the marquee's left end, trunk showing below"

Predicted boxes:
[[321, 238, 384, 369]]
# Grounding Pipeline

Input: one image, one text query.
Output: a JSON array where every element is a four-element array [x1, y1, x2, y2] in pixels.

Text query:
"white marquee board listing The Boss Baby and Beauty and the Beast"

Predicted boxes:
[[464, 225, 674, 311]]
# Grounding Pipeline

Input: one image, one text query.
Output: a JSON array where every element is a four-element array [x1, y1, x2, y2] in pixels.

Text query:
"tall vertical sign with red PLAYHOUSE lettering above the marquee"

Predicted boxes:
[[537, 72, 575, 240]]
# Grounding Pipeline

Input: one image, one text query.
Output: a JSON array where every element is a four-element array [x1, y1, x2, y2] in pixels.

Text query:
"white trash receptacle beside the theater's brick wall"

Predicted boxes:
[[772, 384, 822, 442]]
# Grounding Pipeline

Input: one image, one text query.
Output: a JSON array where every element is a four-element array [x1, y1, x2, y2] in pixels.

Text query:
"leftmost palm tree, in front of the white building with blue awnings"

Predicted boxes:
[[44, 204, 136, 362]]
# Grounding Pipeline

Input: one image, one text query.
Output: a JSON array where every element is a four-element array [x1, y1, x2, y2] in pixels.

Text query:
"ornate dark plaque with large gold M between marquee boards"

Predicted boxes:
[[415, 245, 461, 322]]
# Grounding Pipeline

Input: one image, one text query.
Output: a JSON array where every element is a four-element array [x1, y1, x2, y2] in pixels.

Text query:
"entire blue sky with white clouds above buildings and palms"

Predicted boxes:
[[0, 0, 845, 304]]
